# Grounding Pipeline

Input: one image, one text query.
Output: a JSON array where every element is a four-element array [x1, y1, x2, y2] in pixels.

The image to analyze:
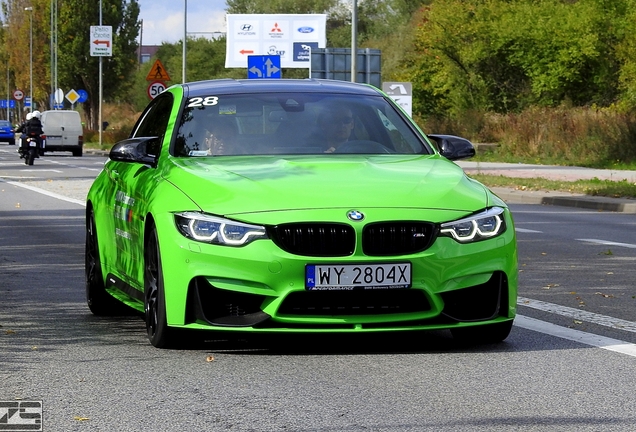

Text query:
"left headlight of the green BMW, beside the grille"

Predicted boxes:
[[174, 212, 267, 246]]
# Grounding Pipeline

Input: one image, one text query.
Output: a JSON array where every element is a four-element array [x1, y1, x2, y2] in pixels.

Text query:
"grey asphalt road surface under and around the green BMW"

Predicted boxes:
[[0, 144, 636, 432]]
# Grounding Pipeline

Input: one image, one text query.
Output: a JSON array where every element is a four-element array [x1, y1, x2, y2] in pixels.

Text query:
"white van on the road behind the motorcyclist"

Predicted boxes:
[[40, 110, 84, 156]]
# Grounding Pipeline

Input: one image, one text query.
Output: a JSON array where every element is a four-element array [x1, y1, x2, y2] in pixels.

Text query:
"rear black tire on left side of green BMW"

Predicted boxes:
[[84, 209, 128, 316]]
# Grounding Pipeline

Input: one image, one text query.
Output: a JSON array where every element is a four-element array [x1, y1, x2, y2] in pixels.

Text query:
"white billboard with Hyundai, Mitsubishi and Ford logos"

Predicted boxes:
[[225, 14, 327, 68]]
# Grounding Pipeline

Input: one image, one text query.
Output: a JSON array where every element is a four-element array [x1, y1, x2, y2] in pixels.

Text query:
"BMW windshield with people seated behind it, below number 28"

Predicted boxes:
[[173, 93, 433, 157]]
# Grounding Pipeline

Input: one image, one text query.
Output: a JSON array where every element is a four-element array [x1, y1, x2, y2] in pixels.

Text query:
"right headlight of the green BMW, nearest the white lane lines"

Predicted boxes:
[[440, 207, 506, 243]]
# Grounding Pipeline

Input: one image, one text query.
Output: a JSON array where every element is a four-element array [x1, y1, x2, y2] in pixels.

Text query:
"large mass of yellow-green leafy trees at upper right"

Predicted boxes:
[[403, 0, 632, 115]]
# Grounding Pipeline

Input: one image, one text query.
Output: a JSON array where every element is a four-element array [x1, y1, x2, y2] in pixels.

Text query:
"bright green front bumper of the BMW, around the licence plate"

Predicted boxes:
[[158, 211, 517, 332]]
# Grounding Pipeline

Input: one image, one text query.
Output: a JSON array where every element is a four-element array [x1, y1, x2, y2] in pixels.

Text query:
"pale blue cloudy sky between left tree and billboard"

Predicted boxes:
[[137, 0, 226, 45]]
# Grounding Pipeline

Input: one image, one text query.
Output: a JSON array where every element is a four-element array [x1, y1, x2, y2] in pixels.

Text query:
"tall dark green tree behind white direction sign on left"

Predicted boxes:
[[58, 0, 141, 129]]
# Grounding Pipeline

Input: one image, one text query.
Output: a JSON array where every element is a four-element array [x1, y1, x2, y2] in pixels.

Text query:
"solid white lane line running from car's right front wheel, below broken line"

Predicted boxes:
[[514, 315, 636, 357]]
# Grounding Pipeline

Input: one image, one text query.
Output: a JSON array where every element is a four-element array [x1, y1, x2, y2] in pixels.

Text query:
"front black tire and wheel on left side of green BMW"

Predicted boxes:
[[144, 227, 175, 348]]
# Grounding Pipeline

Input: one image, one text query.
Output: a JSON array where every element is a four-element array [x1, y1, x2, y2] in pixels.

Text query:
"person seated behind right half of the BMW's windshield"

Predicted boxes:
[[312, 103, 354, 153]]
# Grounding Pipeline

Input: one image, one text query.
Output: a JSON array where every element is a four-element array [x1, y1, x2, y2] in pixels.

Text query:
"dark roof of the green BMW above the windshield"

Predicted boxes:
[[181, 78, 380, 97]]
